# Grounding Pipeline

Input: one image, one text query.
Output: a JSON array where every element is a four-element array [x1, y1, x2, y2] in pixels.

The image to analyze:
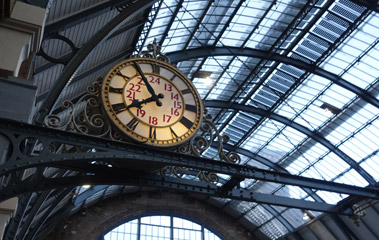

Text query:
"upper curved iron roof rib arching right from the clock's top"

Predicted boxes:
[[166, 46, 379, 108]]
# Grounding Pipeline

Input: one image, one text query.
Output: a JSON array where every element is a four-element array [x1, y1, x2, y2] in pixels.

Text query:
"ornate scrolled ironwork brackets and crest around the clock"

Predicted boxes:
[[44, 39, 241, 183]]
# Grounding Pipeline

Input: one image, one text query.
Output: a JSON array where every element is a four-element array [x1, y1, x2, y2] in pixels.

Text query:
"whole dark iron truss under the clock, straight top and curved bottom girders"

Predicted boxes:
[[0, 119, 379, 214]]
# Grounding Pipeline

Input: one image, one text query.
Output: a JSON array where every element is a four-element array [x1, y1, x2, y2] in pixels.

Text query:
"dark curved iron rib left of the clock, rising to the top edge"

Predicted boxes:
[[35, 0, 157, 124]]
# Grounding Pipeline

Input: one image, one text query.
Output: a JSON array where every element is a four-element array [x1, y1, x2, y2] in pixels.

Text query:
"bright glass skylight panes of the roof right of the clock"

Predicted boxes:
[[134, 0, 379, 239]]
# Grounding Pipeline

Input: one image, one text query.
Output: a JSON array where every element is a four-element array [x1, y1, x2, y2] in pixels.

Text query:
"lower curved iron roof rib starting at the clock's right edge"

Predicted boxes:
[[205, 100, 377, 186]]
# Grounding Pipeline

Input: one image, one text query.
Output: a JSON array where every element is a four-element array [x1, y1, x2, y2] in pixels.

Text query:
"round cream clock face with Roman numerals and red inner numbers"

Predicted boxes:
[[101, 58, 203, 147]]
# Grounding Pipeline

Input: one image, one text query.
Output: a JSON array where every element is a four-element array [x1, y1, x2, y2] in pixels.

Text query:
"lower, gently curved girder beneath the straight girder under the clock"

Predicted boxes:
[[17, 172, 352, 215]]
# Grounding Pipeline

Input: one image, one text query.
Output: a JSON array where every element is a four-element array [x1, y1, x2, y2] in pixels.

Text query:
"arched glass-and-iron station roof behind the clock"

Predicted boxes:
[[3, 0, 379, 239]]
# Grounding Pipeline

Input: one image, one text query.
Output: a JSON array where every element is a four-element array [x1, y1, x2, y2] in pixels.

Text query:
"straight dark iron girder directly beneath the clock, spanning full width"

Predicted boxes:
[[0, 119, 379, 202]]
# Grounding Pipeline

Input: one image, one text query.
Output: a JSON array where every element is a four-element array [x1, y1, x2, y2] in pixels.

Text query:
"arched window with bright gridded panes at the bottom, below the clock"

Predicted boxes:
[[104, 216, 222, 240]]
